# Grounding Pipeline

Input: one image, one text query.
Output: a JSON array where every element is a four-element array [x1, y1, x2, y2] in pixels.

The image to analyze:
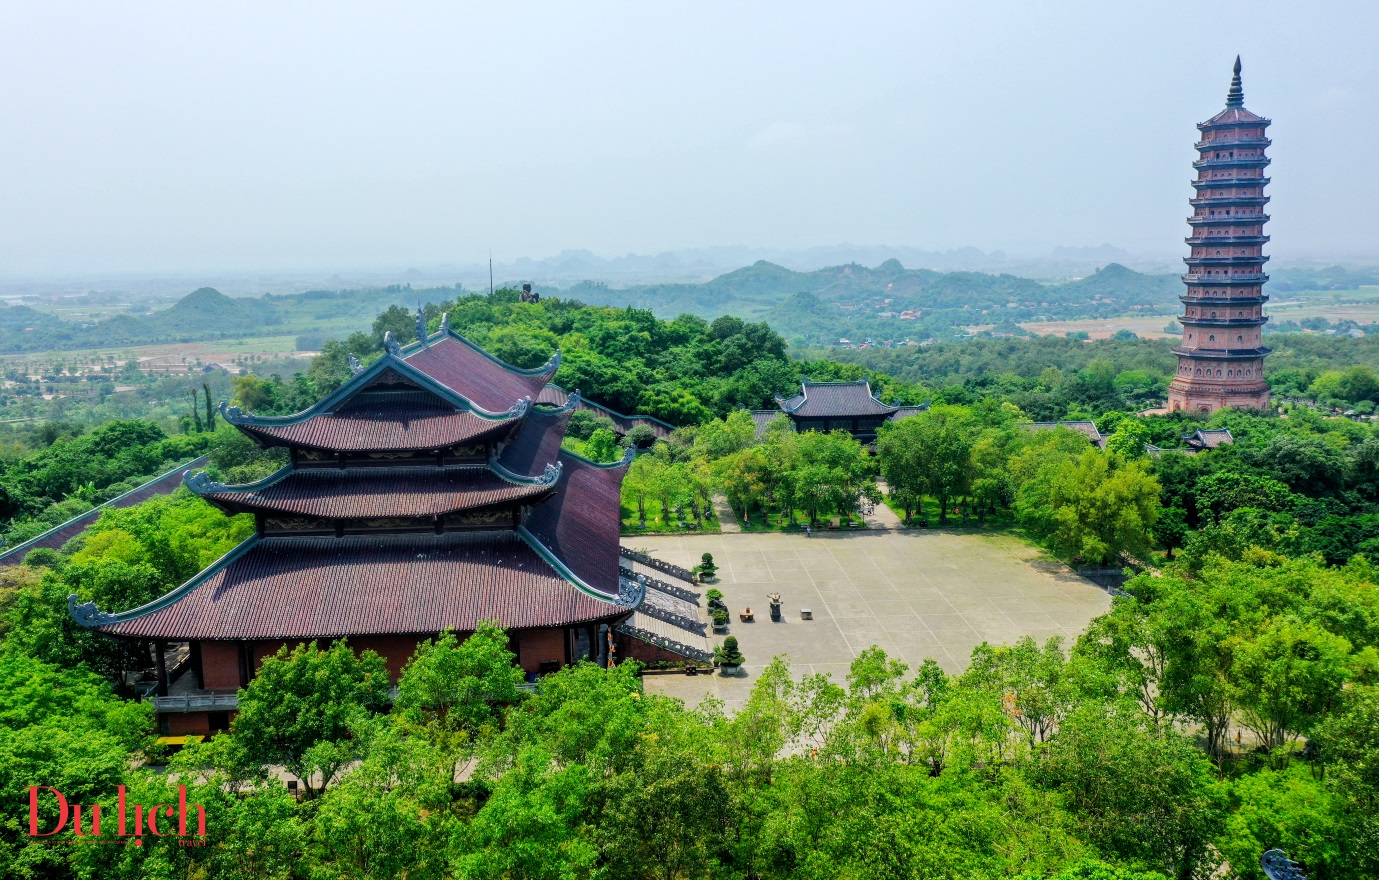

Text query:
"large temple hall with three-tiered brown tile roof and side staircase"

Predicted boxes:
[[69, 317, 712, 734]]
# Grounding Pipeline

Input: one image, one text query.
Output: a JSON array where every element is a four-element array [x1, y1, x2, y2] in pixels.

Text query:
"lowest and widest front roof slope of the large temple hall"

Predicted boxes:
[[68, 531, 643, 641]]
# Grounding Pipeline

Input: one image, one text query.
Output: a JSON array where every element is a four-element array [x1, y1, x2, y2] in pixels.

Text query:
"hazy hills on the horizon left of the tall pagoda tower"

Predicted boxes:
[[0, 258, 1180, 353]]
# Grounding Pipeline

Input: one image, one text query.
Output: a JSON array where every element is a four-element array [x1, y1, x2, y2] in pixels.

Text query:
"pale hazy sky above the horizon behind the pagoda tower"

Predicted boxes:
[[0, 0, 1379, 274]]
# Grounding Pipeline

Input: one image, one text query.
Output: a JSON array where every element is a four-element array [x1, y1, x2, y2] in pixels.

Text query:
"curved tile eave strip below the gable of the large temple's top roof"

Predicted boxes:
[[240, 399, 519, 452]]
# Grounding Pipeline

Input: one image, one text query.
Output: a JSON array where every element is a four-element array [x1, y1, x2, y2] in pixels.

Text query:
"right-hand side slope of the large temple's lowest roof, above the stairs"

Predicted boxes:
[[517, 450, 634, 593]]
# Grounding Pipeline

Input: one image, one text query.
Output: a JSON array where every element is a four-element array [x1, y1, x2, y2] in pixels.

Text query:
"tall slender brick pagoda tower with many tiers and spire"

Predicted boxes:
[[1168, 58, 1270, 412]]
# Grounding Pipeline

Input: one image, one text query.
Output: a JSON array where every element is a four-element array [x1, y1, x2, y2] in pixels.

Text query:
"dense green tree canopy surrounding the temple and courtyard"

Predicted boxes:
[[8, 291, 1379, 880]]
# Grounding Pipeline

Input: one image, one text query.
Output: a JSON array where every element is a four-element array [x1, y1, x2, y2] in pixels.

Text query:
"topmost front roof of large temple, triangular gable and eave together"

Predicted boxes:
[[221, 354, 531, 452]]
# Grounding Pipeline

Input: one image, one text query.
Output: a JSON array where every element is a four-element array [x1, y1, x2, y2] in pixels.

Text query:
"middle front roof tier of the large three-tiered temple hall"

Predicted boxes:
[[186, 455, 558, 520]]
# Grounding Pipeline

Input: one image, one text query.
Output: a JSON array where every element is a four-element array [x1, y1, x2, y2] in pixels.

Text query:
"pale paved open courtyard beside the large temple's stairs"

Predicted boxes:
[[623, 530, 1110, 709]]
